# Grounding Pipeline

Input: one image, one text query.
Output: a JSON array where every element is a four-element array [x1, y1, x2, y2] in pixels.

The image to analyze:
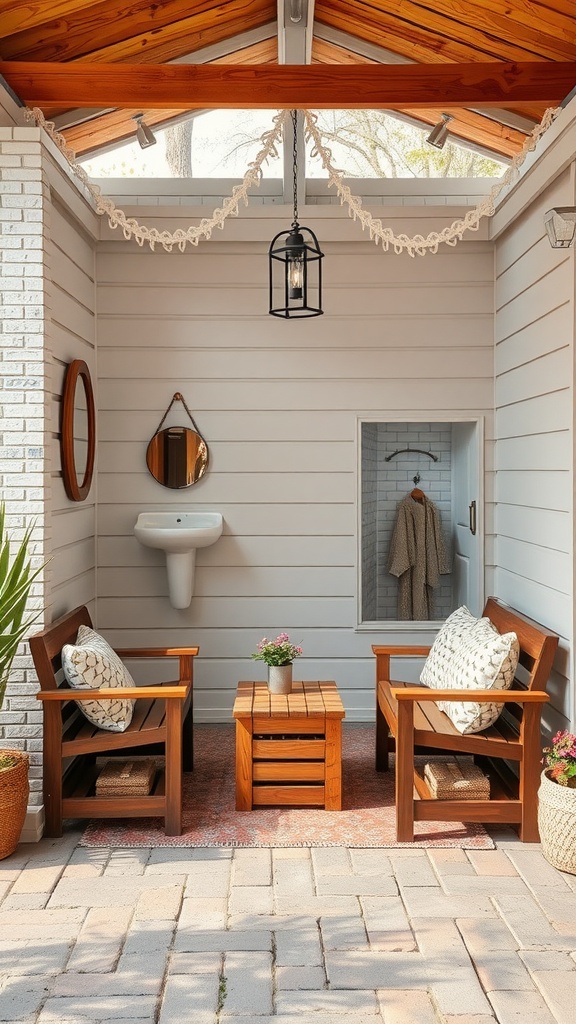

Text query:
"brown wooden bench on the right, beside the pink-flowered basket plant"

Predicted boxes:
[[372, 597, 559, 843]]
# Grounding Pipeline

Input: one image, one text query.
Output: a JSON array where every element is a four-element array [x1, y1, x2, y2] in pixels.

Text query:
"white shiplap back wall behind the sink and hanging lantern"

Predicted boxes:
[[96, 208, 493, 720]]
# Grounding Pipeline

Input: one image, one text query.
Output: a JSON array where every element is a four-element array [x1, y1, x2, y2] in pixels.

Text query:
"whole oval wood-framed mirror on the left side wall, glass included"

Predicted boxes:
[[60, 359, 96, 502]]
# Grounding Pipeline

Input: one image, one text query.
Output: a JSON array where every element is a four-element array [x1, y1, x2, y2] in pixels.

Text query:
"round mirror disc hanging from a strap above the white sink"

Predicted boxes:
[[146, 427, 208, 487]]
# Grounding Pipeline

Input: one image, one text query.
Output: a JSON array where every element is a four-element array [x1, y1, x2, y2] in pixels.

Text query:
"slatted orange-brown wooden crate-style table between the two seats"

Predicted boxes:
[[233, 681, 345, 811]]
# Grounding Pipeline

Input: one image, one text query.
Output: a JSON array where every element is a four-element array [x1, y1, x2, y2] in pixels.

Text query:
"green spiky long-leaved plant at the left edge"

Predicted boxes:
[[0, 502, 42, 771]]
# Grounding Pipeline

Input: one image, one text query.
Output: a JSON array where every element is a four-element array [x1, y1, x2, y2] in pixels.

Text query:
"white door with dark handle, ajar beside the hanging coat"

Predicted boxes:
[[452, 422, 484, 615]]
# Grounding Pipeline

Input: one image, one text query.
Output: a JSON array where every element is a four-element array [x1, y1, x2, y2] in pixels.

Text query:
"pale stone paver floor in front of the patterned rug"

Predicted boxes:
[[0, 830, 576, 1024]]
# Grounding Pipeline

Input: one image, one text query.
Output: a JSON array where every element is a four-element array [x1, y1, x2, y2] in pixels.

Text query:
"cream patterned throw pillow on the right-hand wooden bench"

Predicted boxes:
[[420, 605, 520, 734]]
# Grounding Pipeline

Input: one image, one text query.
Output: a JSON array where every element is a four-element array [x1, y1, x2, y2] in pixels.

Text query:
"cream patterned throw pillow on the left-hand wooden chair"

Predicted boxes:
[[61, 626, 135, 732]]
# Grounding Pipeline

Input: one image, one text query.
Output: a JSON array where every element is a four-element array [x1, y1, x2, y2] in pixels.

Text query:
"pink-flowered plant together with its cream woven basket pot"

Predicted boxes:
[[538, 730, 576, 874]]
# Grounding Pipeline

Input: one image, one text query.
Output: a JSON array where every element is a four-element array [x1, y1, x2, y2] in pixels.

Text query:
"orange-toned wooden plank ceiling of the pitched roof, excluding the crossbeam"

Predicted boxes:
[[0, 0, 576, 157]]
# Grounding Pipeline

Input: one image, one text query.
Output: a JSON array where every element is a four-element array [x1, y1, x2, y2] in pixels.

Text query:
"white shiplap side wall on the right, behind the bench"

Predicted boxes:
[[495, 169, 575, 732]]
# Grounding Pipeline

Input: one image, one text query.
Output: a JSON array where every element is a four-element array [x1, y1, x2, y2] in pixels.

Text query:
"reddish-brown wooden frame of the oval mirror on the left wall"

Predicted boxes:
[[60, 359, 96, 502]]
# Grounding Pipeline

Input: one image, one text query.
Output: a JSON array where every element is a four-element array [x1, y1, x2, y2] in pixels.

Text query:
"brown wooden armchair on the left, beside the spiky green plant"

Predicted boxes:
[[30, 606, 198, 837]]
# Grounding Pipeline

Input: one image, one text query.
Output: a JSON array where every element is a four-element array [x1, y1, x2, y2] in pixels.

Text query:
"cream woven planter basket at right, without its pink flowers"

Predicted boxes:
[[538, 771, 576, 874]]
